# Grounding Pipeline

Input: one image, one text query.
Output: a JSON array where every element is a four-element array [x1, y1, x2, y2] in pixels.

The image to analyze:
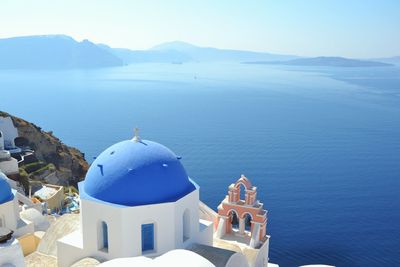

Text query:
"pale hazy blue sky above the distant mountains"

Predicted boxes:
[[0, 0, 400, 58]]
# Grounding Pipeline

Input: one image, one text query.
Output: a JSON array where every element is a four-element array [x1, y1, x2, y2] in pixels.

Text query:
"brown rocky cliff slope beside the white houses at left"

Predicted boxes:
[[0, 111, 89, 185]]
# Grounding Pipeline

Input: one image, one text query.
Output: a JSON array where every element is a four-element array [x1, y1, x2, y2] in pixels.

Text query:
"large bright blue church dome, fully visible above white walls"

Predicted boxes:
[[80, 137, 195, 206]]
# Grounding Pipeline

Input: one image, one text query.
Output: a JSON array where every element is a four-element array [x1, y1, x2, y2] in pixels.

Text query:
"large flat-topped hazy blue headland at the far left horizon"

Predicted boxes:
[[0, 35, 123, 69]]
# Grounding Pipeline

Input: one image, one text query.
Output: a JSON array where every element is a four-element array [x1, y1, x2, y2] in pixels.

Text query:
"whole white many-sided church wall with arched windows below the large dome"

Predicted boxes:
[[72, 189, 203, 264]]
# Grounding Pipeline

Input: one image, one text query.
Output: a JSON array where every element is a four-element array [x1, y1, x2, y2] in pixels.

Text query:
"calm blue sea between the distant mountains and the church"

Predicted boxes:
[[0, 63, 400, 266]]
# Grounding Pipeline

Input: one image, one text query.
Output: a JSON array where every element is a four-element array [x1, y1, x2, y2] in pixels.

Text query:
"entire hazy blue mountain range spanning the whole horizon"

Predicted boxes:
[[0, 35, 392, 69]]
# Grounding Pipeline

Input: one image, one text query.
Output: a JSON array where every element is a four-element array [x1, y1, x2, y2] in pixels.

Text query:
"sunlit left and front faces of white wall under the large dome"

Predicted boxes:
[[81, 200, 181, 259]]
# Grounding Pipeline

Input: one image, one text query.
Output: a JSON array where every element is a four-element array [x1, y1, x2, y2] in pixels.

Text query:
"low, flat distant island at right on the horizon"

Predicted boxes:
[[243, 57, 393, 67]]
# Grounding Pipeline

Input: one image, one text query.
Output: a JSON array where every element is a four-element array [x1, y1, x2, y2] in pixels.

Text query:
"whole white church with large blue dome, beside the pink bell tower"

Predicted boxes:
[[57, 132, 268, 267]]
